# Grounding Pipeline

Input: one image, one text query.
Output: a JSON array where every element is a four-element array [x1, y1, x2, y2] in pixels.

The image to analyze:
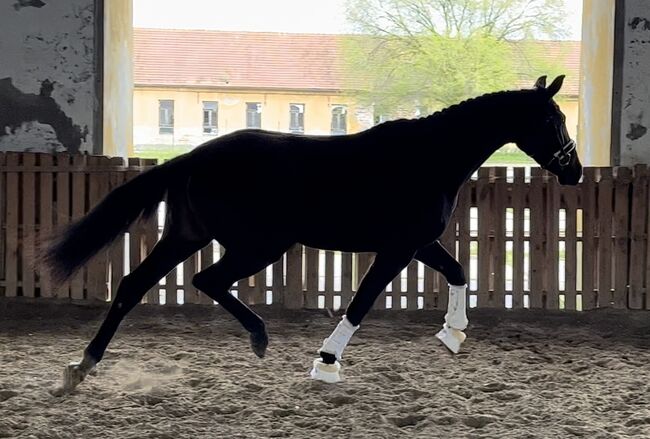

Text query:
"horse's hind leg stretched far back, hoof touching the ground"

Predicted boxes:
[[53, 234, 205, 396]]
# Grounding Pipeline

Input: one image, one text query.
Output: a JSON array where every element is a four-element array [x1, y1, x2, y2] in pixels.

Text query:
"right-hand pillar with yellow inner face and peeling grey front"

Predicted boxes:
[[578, 0, 650, 166]]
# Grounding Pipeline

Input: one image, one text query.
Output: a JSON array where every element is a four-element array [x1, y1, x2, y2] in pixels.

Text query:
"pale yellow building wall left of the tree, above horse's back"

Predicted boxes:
[[133, 86, 372, 150]]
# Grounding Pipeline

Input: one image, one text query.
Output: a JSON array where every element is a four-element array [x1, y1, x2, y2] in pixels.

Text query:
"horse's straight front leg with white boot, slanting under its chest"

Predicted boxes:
[[310, 249, 415, 383]]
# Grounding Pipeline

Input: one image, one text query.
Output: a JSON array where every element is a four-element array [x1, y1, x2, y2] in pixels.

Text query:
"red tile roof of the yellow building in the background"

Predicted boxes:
[[134, 28, 580, 95]]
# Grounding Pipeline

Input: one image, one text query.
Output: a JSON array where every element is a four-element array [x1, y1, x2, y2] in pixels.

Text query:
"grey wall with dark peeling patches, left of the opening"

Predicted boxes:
[[0, 0, 101, 152]]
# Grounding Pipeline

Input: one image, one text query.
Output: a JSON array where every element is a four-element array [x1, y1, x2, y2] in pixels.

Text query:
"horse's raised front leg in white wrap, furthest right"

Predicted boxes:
[[415, 241, 469, 354]]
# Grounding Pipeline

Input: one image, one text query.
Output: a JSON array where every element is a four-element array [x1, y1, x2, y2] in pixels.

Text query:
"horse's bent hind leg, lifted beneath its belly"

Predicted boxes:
[[192, 245, 289, 358]]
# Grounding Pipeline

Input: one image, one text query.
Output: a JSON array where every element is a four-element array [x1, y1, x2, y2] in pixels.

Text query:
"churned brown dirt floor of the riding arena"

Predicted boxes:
[[0, 300, 650, 439]]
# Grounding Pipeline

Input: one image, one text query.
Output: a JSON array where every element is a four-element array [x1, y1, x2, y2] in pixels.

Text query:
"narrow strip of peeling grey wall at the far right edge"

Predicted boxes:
[[612, 0, 650, 166]]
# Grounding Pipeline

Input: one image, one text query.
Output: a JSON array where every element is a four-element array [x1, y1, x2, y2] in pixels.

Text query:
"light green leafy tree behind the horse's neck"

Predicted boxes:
[[343, 0, 565, 117]]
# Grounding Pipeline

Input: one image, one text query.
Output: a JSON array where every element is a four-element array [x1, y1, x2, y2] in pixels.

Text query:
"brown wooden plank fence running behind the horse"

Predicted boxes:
[[0, 153, 650, 310]]
